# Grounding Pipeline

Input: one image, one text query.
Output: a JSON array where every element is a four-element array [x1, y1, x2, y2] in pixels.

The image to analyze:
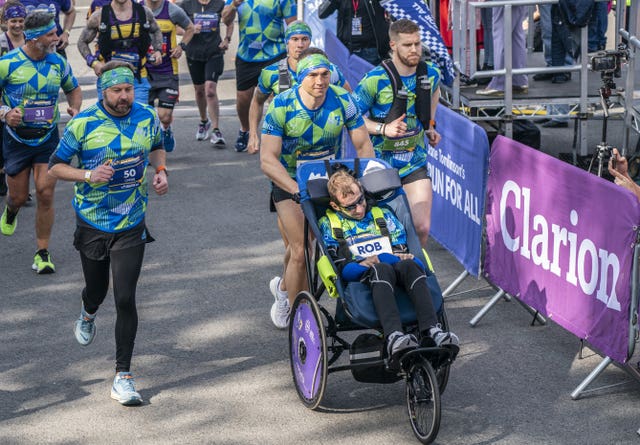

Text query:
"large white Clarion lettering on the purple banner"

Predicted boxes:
[[500, 181, 621, 312]]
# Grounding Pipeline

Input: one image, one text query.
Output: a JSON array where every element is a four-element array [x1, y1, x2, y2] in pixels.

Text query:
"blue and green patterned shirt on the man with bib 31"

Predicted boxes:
[[0, 48, 78, 147]]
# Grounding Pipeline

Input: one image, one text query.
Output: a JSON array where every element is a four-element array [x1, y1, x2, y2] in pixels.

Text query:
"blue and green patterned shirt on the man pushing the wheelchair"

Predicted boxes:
[[262, 85, 364, 178]]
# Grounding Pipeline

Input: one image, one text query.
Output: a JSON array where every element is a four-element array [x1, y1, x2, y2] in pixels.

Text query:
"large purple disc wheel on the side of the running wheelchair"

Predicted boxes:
[[289, 292, 327, 409]]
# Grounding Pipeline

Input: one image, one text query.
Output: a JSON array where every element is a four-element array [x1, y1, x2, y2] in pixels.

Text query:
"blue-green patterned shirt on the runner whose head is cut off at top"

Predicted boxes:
[[225, 0, 297, 62]]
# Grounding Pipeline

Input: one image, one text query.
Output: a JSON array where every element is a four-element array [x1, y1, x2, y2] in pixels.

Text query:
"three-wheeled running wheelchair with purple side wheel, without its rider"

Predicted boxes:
[[289, 159, 458, 443]]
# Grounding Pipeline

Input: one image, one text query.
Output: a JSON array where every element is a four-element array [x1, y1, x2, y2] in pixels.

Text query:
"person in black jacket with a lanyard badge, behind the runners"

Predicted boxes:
[[318, 0, 389, 65]]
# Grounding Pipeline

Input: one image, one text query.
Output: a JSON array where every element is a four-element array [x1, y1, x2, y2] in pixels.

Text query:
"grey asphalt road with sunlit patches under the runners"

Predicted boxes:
[[0, 2, 640, 445]]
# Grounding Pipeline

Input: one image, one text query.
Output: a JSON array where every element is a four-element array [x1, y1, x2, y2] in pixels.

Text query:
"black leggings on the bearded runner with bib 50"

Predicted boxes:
[[80, 244, 145, 372]]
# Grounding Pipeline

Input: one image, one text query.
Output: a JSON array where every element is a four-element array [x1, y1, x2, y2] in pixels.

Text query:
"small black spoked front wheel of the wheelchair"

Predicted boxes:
[[406, 359, 440, 443]]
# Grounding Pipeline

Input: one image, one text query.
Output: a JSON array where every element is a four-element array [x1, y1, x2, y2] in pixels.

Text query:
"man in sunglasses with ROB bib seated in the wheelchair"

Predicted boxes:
[[319, 169, 458, 364]]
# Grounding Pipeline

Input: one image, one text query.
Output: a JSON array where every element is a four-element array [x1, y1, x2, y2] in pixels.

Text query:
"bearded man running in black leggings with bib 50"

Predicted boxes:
[[49, 60, 169, 405]]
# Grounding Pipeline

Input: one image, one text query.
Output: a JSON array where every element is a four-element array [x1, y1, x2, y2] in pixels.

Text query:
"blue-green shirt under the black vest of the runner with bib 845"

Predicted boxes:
[[354, 63, 440, 177]]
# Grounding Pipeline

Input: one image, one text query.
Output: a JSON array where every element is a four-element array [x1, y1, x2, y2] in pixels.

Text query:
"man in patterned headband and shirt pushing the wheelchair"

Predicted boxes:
[[260, 54, 374, 329]]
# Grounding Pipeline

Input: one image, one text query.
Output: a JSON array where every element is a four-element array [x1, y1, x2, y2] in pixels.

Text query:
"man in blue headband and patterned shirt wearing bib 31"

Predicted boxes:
[[0, 11, 82, 274]]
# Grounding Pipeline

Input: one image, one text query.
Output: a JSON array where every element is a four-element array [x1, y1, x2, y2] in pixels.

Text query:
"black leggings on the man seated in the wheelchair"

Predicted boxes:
[[364, 260, 438, 336]]
